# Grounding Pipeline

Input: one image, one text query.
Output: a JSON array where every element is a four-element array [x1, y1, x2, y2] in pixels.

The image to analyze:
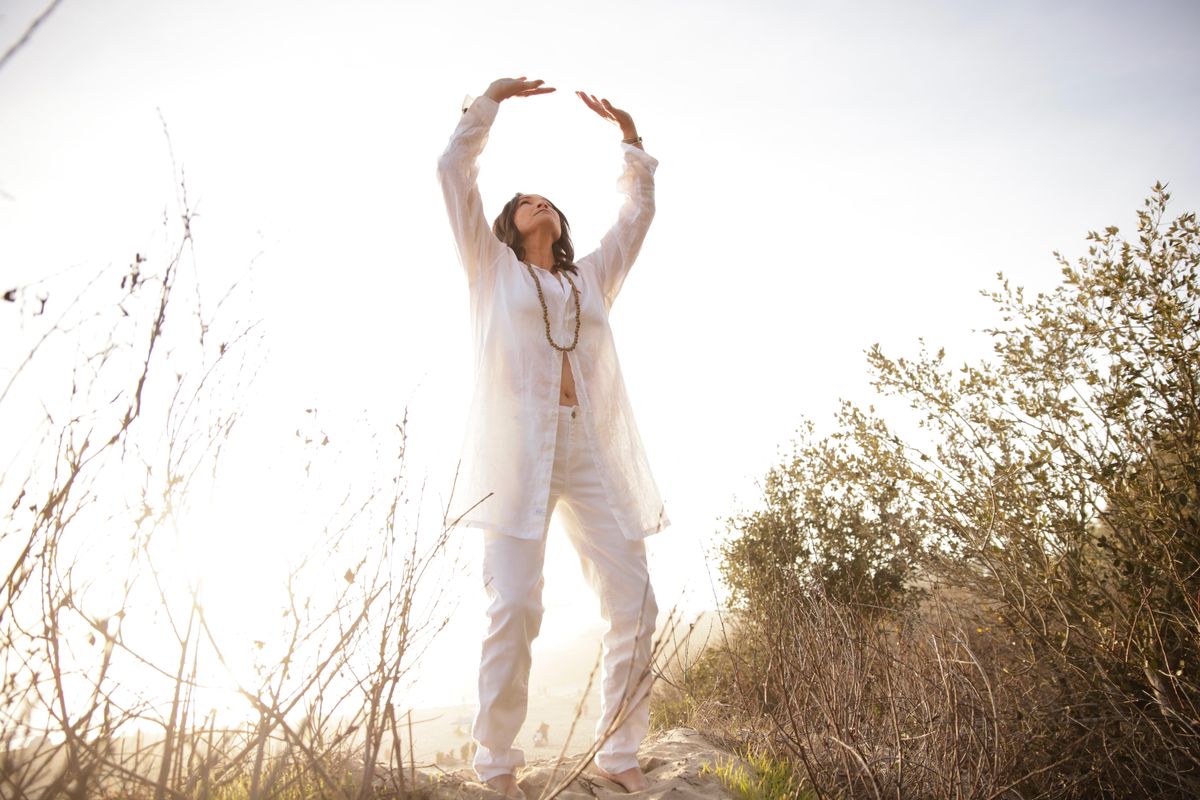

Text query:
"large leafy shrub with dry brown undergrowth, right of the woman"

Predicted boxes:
[[694, 185, 1200, 799]]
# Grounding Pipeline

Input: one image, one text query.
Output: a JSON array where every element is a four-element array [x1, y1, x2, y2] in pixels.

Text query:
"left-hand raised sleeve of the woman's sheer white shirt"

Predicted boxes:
[[438, 95, 508, 284]]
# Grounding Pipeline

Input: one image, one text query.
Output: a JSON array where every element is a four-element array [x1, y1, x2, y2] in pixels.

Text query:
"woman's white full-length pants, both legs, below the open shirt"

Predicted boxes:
[[472, 405, 659, 781]]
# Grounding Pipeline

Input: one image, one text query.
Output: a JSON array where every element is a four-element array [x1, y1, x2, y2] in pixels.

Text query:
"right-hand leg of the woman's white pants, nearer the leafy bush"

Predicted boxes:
[[562, 410, 659, 772]]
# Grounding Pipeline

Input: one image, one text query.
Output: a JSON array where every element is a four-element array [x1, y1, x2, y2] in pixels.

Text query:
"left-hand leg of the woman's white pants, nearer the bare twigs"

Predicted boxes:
[[472, 407, 566, 781]]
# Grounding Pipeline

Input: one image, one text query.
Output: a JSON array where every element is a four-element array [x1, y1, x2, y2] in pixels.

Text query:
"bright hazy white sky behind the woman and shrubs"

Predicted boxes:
[[0, 0, 1200, 719]]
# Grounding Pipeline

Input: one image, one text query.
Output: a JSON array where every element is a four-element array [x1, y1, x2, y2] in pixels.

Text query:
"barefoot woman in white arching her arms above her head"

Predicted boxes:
[[438, 76, 671, 798]]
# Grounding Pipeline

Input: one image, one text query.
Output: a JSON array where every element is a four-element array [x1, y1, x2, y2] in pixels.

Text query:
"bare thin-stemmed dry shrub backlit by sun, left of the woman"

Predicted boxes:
[[0, 164, 456, 800]]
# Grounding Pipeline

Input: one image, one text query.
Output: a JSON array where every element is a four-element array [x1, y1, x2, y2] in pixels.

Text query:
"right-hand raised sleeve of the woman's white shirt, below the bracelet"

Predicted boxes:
[[580, 142, 659, 307]]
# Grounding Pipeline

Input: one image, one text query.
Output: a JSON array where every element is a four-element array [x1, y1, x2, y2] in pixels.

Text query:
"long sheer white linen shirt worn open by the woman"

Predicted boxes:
[[438, 95, 671, 540]]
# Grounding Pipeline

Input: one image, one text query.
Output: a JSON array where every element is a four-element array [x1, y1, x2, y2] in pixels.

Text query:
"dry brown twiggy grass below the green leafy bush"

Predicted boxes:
[[655, 575, 1185, 799]]
